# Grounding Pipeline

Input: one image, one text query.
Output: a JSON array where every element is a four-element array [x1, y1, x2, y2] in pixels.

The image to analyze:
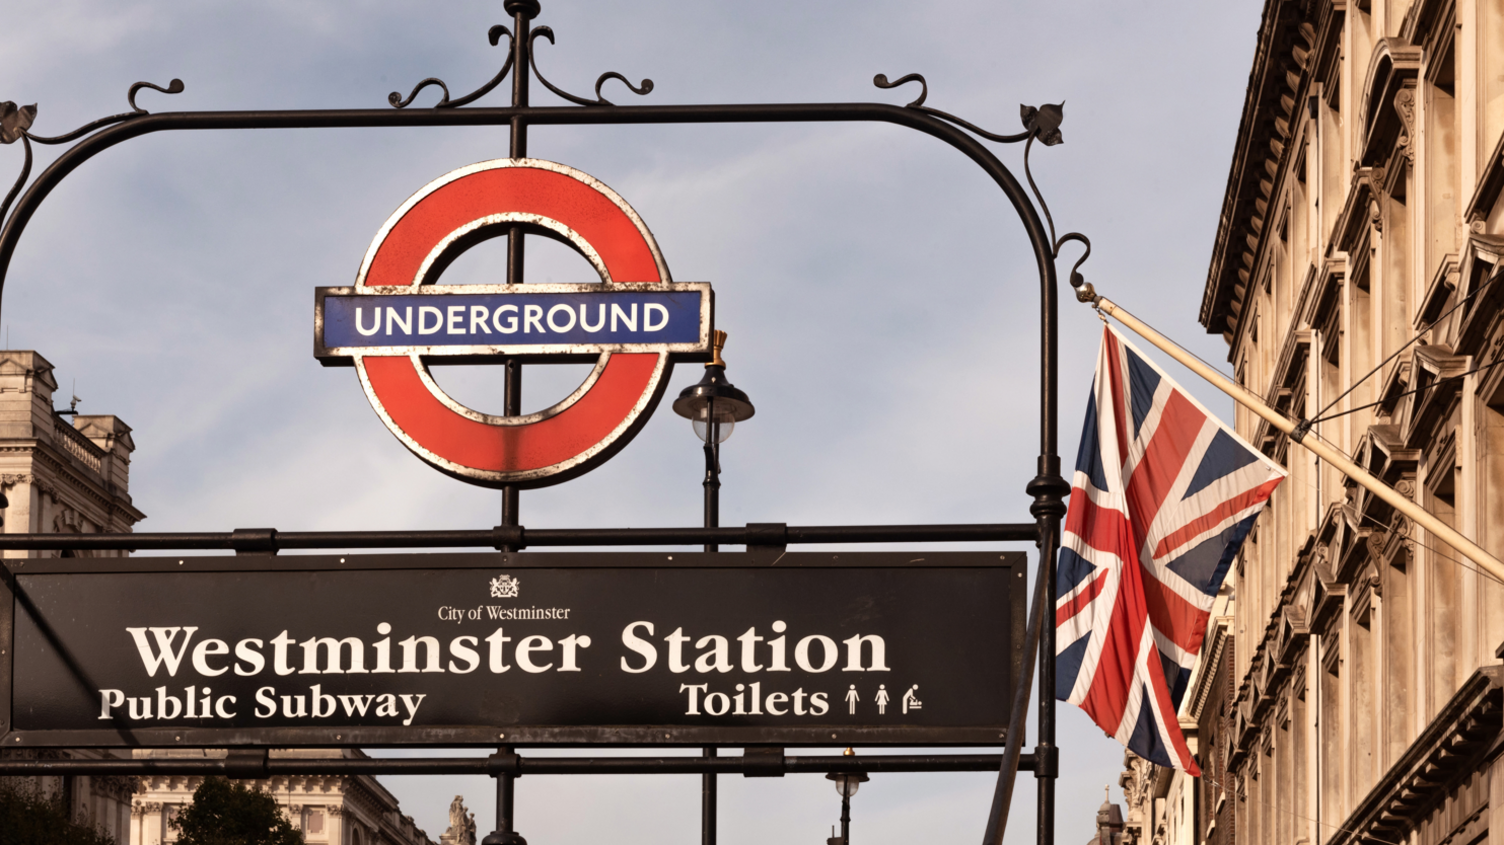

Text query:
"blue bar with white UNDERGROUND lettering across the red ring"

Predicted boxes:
[[323, 289, 701, 349]]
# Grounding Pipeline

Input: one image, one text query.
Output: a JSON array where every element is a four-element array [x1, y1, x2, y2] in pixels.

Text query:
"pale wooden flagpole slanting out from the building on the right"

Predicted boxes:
[[1075, 284, 1504, 580]]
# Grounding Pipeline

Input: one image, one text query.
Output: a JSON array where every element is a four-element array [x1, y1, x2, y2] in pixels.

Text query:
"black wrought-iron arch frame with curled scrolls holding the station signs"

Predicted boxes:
[[0, 0, 1090, 845]]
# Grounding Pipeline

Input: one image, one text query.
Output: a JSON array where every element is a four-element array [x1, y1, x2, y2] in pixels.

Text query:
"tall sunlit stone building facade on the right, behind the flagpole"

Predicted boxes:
[[1197, 0, 1504, 845]]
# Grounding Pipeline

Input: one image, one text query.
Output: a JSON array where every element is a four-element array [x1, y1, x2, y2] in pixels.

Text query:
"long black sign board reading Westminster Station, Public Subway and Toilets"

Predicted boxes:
[[0, 550, 1026, 747]]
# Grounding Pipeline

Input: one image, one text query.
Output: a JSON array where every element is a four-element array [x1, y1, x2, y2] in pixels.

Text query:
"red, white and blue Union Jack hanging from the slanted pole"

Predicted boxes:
[[1054, 328, 1284, 776]]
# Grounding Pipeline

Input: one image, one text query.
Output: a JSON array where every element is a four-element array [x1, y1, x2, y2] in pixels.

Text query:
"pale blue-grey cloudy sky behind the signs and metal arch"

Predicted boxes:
[[0, 0, 1260, 845]]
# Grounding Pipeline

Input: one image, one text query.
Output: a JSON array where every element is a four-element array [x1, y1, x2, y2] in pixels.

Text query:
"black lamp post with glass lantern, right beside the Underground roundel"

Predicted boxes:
[[674, 329, 755, 845]]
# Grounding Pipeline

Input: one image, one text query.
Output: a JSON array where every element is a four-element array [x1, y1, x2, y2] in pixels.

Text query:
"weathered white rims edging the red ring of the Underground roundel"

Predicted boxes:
[[345, 158, 674, 487]]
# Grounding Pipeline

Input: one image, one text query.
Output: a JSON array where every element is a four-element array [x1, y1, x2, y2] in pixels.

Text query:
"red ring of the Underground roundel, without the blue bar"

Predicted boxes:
[[355, 159, 672, 487]]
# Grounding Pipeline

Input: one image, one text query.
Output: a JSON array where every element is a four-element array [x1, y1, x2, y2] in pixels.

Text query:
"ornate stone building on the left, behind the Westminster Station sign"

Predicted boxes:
[[0, 350, 442, 845]]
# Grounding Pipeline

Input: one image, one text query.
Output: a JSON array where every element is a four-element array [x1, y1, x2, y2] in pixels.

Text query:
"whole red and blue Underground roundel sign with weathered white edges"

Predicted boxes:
[[314, 159, 713, 487]]
